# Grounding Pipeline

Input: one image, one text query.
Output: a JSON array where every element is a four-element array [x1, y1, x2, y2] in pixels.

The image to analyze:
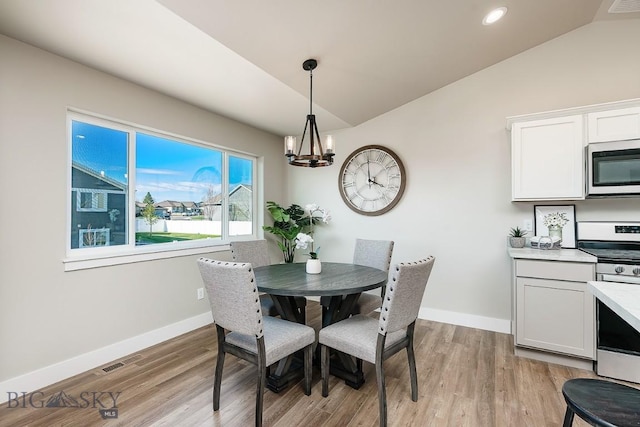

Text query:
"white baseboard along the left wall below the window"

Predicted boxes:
[[0, 312, 213, 403]]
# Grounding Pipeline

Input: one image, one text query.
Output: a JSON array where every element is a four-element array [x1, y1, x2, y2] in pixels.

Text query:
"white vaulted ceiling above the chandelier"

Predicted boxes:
[[0, 0, 640, 135]]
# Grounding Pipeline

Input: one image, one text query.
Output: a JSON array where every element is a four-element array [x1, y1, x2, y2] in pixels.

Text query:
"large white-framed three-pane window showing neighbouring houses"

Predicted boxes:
[[68, 112, 257, 257]]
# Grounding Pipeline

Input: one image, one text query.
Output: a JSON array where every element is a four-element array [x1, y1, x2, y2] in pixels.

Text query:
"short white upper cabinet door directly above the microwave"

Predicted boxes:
[[587, 107, 640, 142]]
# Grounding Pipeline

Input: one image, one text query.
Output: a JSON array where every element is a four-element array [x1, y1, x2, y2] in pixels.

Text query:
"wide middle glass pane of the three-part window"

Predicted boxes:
[[135, 133, 222, 245]]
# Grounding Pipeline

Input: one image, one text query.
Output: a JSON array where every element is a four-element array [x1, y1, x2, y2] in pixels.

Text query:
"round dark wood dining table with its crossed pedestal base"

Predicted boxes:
[[254, 262, 388, 392]]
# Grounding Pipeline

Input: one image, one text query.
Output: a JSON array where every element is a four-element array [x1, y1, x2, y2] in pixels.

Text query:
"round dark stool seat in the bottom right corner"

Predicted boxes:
[[562, 378, 640, 427]]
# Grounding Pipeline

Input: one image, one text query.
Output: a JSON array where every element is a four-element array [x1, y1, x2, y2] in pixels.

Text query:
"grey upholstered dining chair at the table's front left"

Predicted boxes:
[[198, 258, 315, 426]]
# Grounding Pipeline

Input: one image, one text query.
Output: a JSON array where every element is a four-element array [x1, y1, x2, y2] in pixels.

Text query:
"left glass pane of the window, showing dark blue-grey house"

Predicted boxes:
[[71, 120, 129, 248]]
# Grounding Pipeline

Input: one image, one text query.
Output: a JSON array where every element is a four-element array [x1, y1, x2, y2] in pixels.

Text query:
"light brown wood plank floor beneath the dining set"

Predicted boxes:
[[0, 302, 595, 427]]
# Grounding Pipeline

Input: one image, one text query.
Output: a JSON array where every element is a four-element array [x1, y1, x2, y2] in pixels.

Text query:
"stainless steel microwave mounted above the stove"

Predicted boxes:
[[587, 139, 640, 197]]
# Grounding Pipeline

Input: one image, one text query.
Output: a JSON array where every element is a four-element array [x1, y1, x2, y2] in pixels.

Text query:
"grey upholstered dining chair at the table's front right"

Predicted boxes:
[[318, 257, 435, 426]]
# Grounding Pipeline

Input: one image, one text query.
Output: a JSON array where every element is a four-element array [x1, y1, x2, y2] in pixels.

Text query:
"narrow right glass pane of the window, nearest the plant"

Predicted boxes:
[[229, 156, 253, 236]]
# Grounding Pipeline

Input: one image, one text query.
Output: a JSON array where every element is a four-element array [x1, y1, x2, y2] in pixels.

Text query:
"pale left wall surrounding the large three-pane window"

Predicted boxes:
[[0, 36, 286, 386]]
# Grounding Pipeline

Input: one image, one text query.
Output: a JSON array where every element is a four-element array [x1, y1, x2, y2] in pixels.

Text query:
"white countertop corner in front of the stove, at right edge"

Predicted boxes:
[[587, 282, 640, 331]]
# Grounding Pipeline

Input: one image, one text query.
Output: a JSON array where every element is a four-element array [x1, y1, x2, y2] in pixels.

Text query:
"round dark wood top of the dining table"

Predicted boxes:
[[254, 262, 388, 296]]
